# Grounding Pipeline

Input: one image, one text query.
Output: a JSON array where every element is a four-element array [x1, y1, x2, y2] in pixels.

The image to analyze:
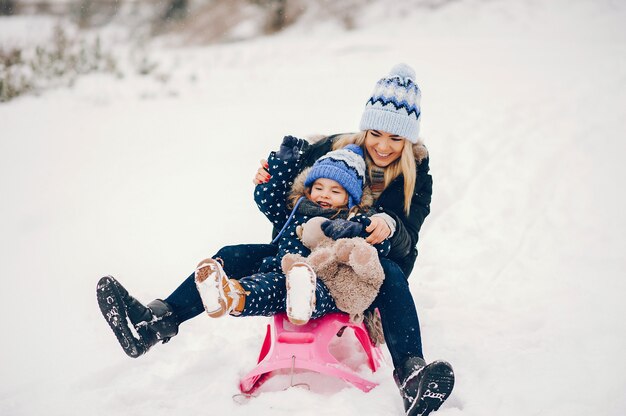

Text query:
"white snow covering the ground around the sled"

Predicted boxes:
[[0, 0, 626, 416]]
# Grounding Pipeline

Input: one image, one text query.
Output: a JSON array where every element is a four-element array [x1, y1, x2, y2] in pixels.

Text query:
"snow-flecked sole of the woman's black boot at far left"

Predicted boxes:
[[96, 276, 145, 358]]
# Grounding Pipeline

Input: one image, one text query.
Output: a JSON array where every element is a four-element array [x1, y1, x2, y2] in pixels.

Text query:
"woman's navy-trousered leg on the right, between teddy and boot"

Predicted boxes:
[[370, 258, 424, 368]]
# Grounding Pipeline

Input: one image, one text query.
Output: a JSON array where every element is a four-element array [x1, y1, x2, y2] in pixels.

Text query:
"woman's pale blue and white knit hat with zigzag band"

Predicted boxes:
[[360, 64, 422, 143]]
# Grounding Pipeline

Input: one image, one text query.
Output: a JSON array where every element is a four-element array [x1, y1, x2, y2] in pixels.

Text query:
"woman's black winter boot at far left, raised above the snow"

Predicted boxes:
[[96, 276, 179, 358]]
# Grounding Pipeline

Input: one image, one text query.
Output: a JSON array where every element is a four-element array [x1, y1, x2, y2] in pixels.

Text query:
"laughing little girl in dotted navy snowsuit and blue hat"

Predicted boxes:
[[195, 141, 389, 325]]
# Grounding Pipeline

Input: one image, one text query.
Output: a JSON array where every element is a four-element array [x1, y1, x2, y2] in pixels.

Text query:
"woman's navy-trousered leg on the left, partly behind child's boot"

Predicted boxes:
[[165, 244, 277, 323]]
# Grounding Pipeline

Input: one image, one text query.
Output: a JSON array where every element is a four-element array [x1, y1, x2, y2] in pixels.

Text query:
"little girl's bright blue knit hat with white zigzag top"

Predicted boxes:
[[304, 144, 365, 208]]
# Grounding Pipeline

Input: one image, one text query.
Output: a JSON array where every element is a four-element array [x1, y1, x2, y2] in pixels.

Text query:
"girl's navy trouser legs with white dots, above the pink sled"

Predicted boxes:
[[238, 272, 340, 318]]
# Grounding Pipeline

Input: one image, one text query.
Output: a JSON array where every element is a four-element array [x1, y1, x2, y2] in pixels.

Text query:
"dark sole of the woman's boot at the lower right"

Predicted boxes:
[[406, 361, 454, 416]]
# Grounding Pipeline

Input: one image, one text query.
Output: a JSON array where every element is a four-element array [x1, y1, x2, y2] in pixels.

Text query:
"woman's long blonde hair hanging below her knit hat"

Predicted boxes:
[[333, 131, 422, 215]]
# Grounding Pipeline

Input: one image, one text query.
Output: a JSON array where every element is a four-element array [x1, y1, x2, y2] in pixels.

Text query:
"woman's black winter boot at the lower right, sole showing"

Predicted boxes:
[[393, 357, 454, 416]]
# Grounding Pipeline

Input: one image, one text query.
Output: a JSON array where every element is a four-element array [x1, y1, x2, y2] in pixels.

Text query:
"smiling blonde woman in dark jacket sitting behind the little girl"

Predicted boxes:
[[98, 64, 454, 416]]
